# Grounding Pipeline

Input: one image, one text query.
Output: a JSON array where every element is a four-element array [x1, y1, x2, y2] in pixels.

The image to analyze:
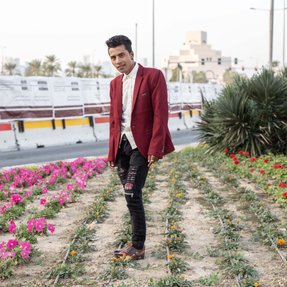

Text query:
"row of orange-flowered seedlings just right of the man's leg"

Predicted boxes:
[[150, 154, 192, 287]]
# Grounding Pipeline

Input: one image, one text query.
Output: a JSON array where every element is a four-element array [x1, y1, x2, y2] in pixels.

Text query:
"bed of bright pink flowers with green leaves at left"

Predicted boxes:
[[0, 158, 106, 279]]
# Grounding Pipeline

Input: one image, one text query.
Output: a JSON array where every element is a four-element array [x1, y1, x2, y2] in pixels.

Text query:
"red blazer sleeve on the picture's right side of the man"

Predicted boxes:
[[148, 70, 168, 158]]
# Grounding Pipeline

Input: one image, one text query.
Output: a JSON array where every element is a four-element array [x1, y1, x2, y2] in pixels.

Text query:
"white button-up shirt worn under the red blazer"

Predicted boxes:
[[121, 63, 139, 149]]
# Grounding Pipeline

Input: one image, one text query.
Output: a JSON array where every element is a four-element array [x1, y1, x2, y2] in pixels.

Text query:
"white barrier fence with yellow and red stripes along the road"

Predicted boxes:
[[0, 76, 222, 152]]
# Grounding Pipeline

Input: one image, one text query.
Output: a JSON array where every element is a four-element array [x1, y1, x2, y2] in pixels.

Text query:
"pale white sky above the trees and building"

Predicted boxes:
[[0, 0, 287, 67]]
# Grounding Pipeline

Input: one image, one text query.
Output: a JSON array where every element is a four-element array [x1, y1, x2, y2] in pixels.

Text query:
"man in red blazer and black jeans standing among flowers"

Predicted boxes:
[[106, 35, 174, 260]]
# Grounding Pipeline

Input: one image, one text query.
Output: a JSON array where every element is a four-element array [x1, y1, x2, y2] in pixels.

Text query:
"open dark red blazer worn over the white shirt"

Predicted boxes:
[[108, 65, 174, 162]]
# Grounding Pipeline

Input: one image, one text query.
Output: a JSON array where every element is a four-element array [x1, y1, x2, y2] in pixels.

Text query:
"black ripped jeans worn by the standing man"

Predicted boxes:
[[116, 135, 148, 249]]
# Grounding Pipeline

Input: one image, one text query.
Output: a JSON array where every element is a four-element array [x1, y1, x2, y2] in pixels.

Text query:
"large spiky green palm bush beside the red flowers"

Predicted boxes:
[[198, 69, 287, 155]]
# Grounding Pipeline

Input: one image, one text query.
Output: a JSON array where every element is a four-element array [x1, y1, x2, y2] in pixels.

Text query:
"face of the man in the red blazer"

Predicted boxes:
[[108, 45, 134, 74]]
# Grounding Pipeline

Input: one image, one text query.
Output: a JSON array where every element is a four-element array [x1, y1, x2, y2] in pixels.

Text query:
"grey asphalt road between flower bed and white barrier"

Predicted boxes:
[[0, 129, 198, 168]]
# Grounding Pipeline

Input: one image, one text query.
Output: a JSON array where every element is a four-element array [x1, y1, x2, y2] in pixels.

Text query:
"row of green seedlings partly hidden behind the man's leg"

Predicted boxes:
[[99, 168, 157, 286]]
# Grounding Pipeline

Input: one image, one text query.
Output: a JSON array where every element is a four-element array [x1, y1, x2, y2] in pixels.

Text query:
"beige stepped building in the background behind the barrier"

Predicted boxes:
[[163, 31, 232, 83]]
